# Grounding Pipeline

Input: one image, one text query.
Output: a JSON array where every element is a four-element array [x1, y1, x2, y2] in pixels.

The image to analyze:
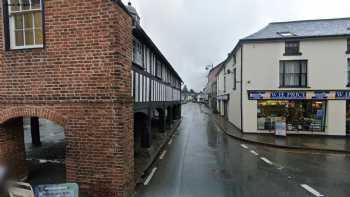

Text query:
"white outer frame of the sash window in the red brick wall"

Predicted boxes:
[[3, 0, 46, 51]]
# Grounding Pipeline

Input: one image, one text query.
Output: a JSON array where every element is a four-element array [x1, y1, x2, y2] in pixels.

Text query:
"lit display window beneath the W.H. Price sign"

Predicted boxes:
[[257, 100, 326, 132]]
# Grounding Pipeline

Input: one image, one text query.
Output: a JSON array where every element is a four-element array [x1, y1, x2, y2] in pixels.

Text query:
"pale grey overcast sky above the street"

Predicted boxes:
[[123, 0, 350, 91]]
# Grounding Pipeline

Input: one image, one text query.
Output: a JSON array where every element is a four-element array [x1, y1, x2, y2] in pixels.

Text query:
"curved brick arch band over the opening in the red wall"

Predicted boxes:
[[0, 107, 67, 127]]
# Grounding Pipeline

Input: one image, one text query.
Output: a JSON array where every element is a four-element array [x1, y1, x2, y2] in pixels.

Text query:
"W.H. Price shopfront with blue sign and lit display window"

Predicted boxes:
[[248, 90, 350, 135]]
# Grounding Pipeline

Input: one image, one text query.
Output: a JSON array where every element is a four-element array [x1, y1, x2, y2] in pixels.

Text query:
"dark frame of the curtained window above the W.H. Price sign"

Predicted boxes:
[[279, 60, 308, 88]]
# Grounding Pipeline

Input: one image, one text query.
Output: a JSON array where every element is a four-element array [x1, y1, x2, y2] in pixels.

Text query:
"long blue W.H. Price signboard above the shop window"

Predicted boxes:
[[248, 90, 350, 100]]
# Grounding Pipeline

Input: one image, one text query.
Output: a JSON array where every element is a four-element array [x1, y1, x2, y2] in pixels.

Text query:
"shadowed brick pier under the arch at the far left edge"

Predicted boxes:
[[0, 118, 28, 180]]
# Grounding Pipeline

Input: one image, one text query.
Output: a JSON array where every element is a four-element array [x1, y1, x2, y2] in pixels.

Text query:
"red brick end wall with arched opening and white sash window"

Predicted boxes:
[[0, 0, 134, 197]]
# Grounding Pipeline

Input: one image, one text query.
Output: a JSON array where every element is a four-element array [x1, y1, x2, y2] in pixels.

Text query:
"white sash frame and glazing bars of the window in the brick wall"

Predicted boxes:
[[7, 0, 44, 49]]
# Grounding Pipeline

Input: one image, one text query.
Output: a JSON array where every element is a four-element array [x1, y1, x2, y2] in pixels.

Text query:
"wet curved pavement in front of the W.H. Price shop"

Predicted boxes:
[[212, 114, 350, 153]]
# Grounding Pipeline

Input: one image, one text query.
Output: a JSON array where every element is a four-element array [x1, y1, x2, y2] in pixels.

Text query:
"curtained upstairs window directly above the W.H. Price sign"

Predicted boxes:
[[280, 60, 307, 87]]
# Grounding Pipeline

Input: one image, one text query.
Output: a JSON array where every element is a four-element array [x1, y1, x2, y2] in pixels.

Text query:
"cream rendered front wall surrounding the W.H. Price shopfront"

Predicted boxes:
[[243, 38, 350, 135]]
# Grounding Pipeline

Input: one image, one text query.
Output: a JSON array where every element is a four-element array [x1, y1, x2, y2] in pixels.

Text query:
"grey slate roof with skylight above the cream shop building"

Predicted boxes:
[[242, 18, 350, 41]]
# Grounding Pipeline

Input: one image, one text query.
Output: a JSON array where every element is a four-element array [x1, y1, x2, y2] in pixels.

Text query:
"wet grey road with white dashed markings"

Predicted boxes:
[[135, 104, 350, 197]]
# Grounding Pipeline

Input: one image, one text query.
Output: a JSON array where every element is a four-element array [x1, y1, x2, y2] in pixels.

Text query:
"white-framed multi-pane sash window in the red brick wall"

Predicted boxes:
[[5, 0, 43, 49]]
